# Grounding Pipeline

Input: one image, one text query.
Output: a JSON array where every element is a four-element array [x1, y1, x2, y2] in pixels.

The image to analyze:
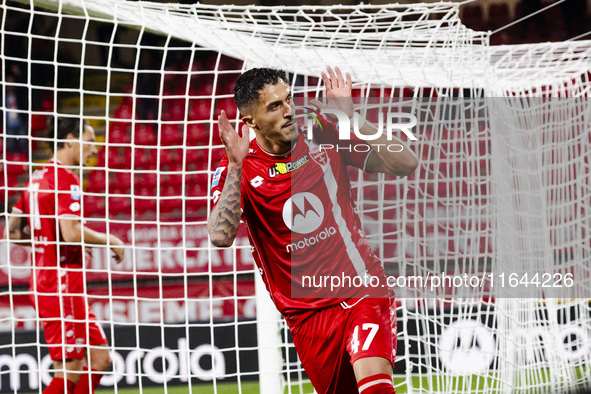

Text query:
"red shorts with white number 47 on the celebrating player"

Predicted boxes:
[[290, 298, 397, 394]]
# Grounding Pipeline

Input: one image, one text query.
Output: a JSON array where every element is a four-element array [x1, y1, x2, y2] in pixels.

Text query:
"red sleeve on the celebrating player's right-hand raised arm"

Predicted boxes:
[[314, 118, 372, 171]]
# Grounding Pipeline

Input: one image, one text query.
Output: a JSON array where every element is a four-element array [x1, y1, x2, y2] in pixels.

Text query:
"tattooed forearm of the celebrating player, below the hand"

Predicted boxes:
[[207, 168, 242, 247]]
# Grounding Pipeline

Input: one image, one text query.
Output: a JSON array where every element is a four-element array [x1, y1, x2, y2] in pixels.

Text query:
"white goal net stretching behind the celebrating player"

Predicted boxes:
[[0, 0, 591, 393]]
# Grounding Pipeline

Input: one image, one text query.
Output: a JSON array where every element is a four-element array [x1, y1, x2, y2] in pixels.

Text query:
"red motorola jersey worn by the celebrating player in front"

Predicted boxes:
[[212, 125, 384, 318]]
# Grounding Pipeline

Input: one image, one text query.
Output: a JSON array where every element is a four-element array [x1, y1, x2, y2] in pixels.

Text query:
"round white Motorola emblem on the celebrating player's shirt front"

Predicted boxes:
[[283, 192, 324, 234]]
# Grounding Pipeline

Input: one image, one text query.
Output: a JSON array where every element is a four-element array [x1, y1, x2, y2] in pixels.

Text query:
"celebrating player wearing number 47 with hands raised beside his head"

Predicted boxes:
[[208, 67, 418, 394]]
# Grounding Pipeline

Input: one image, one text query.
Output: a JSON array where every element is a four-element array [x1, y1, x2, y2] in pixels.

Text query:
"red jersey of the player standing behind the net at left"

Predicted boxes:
[[12, 160, 82, 293]]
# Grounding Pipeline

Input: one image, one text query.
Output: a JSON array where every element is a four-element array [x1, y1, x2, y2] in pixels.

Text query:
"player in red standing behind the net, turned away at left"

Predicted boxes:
[[7, 118, 124, 394]]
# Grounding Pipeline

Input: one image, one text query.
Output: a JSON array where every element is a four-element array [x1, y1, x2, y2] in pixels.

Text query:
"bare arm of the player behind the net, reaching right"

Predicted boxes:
[[59, 219, 125, 263]]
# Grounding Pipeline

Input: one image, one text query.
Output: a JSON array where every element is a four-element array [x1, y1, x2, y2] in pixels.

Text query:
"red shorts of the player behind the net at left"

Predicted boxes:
[[30, 274, 108, 360]]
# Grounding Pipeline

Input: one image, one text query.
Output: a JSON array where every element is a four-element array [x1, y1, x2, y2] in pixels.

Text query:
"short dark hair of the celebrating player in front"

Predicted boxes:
[[234, 67, 291, 112]]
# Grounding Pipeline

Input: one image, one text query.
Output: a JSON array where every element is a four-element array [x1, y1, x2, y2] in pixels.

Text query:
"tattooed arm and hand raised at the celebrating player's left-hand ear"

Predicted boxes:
[[207, 111, 249, 247]]
